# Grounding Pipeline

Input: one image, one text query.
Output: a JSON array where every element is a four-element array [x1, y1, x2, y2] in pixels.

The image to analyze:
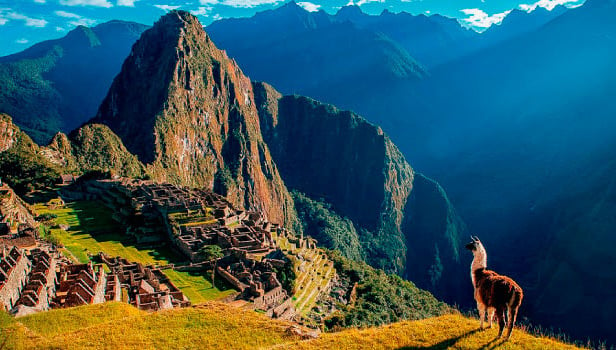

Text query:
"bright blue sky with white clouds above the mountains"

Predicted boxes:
[[0, 0, 583, 56]]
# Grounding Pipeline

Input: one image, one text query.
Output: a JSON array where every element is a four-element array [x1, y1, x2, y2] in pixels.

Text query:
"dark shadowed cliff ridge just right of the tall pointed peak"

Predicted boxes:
[[254, 83, 467, 297]]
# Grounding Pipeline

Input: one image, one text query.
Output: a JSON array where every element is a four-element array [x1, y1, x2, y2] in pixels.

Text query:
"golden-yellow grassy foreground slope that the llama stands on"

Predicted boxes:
[[0, 302, 577, 350]]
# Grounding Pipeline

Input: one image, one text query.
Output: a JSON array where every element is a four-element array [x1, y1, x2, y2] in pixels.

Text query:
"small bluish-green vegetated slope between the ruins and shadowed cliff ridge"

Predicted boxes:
[[291, 191, 363, 260]]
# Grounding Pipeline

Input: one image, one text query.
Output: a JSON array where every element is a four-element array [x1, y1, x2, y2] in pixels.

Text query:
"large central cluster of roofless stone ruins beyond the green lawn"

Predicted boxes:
[[57, 178, 340, 318]]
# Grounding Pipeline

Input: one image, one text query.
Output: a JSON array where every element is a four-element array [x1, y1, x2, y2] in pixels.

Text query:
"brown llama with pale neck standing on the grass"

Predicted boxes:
[[465, 236, 524, 340]]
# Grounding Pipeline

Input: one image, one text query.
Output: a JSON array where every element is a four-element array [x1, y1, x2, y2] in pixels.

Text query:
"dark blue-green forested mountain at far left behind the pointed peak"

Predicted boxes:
[[0, 21, 147, 145]]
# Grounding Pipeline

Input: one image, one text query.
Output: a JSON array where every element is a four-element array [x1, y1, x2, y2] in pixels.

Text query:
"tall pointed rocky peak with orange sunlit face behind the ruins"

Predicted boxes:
[[93, 11, 297, 226]]
